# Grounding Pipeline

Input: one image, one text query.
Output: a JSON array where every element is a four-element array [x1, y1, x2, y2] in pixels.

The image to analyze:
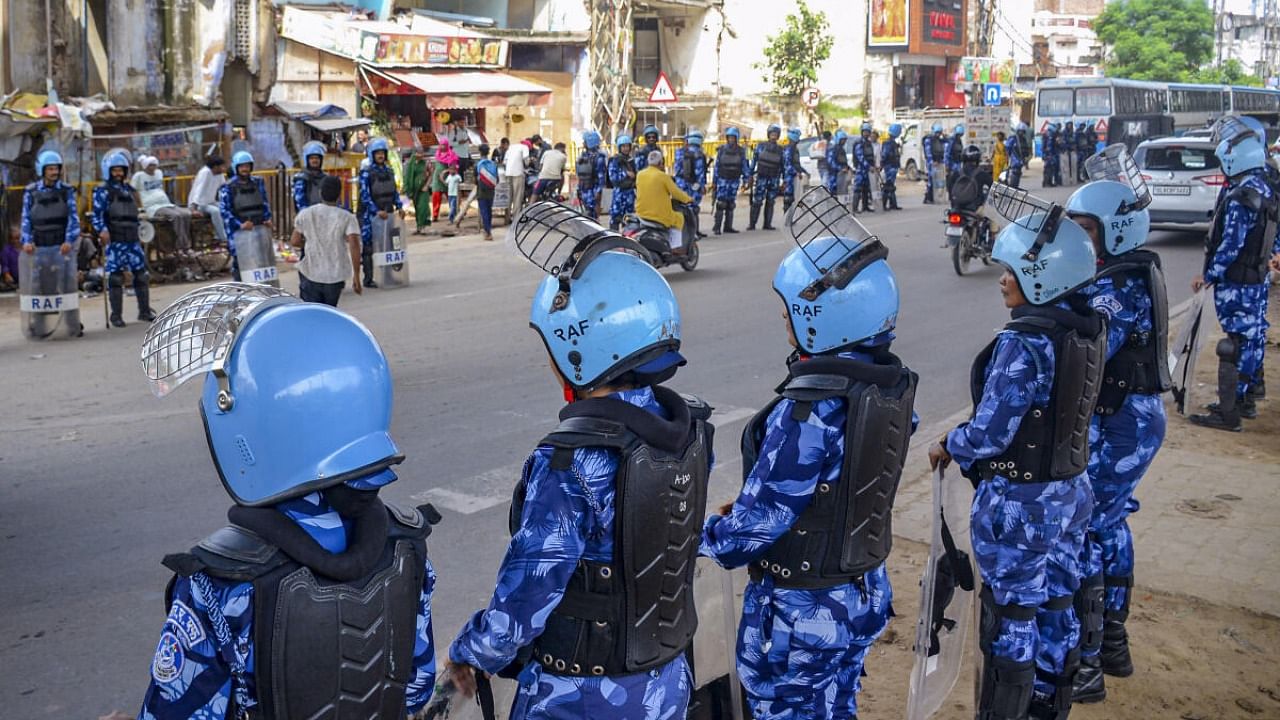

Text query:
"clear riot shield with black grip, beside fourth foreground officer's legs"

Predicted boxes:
[[906, 469, 978, 720]]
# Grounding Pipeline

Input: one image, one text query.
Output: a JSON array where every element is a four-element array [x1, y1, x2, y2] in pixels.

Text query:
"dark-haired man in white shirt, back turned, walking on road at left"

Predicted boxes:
[[291, 176, 364, 307]]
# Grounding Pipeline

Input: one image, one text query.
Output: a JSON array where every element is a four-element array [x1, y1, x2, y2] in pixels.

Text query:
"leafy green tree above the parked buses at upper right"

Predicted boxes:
[[1093, 0, 1213, 81]]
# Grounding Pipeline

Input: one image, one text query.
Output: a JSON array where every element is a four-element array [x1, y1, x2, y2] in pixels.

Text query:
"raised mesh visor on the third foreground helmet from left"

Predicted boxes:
[[787, 187, 888, 300]]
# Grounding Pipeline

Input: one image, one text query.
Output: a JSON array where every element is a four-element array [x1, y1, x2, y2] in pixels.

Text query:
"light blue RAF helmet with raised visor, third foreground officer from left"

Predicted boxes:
[[773, 187, 899, 355]]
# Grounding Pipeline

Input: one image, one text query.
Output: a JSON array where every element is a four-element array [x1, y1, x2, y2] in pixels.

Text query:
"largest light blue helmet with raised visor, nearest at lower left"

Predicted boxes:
[[142, 283, 403, 507]]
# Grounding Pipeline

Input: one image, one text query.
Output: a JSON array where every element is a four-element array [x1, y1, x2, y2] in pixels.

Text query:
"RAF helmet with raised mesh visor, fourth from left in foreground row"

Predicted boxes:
[[988, 183, 1098, 305]]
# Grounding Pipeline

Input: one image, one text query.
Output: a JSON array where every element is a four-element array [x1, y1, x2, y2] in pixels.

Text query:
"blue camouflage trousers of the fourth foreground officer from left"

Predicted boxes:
[[969, 473, 1093, 696]]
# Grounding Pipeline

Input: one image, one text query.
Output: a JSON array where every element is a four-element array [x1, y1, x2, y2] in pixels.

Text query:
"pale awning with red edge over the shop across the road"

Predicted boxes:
[[371, 69, 552, 110]]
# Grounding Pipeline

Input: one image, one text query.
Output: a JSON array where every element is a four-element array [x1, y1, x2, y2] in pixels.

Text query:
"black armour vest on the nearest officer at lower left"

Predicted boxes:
[[164, 498, 440, 720]]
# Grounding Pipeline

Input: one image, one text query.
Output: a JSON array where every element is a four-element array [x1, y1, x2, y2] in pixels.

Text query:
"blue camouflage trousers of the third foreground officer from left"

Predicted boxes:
[[737, 565, 893, 720]]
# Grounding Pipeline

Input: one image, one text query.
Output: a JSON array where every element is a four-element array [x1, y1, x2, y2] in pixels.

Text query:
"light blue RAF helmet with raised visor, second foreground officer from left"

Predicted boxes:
[[508, 201, 685, 391]]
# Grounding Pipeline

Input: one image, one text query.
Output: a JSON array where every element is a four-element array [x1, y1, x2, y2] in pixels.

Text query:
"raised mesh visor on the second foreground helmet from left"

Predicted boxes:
[[507, 200, 646, 278]]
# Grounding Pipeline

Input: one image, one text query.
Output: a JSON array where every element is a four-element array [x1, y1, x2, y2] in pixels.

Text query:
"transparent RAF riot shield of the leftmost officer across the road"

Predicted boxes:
[[18, 241, 83, 340]]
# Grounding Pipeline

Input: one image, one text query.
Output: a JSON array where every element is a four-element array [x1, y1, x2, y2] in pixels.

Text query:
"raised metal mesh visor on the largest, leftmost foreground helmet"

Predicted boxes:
[[141, 283, 292, 397]]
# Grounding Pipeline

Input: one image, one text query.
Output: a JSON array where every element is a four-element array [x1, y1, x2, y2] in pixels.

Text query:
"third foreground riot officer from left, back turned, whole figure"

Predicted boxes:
[[701, 188, 916, 720]]
